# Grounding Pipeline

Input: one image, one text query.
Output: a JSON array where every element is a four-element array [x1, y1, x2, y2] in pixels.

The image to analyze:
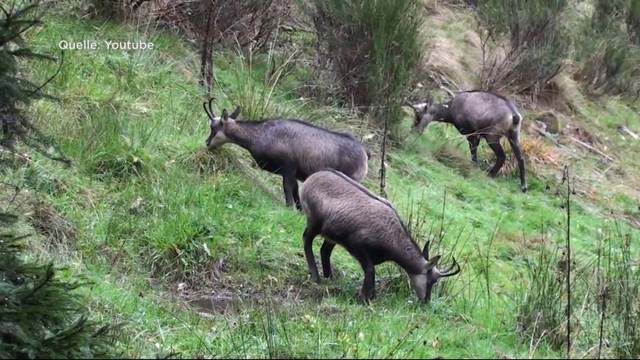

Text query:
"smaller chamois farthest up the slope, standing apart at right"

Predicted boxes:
[[408, 90, 527, 192]]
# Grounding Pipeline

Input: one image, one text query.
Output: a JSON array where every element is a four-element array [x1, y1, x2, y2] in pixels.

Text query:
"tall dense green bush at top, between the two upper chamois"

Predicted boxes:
[[312, 0, 421, 132]]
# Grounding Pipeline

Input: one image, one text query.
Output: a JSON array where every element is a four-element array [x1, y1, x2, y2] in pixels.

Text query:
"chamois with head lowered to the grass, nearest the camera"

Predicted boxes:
[[300, 169, 460, 302]]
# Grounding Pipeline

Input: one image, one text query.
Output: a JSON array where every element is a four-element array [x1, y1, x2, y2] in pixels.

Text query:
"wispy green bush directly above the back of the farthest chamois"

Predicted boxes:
[[476, 0, 570, 95]]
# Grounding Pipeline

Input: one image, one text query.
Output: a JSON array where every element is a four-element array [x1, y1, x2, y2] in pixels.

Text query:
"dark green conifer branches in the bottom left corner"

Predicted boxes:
[[0, 213, 111, 359]]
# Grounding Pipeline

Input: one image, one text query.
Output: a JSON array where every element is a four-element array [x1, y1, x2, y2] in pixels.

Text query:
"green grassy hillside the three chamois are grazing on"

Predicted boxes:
[[5, 2, 640, 358]]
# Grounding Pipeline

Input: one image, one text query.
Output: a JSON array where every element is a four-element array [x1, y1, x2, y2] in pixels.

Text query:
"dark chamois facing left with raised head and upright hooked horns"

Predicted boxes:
[[203, 99, 369, 209]]
